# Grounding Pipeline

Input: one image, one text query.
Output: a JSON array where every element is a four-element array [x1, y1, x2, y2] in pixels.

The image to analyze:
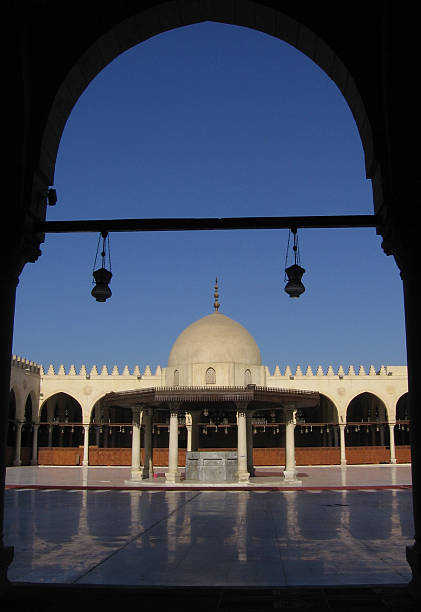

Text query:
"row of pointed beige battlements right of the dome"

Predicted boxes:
[[266, 365, 408, 380]]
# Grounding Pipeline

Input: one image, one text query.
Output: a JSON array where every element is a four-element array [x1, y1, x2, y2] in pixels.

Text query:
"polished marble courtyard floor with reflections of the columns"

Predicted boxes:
[[5, 466, 413, 588]]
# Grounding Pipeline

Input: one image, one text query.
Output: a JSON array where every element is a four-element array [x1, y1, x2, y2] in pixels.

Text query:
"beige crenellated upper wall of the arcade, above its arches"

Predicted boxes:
[[10, 357, 408, 423]]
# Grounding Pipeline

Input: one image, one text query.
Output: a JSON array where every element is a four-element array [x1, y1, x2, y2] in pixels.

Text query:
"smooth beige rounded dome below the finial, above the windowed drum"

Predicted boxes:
[[168, 312, 262, 366]]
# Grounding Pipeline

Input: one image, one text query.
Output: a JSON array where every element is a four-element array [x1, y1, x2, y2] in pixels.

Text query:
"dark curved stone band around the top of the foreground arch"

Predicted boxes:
[[39, 0, 379, 209]]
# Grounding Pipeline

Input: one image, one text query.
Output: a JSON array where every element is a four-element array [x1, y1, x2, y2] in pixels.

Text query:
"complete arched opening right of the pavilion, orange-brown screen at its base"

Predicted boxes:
[[345, 392, 390, 464]]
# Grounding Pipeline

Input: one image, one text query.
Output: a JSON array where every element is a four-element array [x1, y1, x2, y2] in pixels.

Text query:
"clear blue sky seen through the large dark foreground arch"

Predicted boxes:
[[13, 23, 406, 370]]
